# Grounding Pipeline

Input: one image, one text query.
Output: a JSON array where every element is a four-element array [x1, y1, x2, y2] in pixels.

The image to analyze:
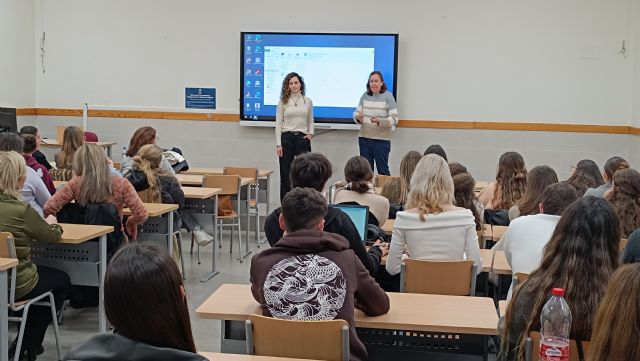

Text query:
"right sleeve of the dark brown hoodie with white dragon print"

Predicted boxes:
[[354, 253, 390, 316]]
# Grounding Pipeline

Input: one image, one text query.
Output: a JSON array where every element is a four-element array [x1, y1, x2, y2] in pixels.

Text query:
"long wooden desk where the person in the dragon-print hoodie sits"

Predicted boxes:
[[196, 284, 498, 357]]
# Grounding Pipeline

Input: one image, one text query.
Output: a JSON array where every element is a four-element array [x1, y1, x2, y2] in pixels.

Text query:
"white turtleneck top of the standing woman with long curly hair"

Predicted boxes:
[[276, 93, 314, 146]]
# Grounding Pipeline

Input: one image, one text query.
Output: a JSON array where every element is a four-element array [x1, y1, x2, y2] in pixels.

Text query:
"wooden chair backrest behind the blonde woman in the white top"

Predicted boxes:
[[400, 259, 477, 296]]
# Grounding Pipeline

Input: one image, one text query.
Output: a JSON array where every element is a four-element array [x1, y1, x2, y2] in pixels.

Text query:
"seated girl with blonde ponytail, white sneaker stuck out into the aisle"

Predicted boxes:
[[127, 144, 213, 244]]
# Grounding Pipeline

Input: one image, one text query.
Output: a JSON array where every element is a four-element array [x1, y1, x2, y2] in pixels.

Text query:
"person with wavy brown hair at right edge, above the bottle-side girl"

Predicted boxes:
[[607, 169, 640, 238]]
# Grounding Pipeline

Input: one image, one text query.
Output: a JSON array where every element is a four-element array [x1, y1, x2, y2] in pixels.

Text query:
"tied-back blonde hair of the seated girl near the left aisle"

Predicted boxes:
[[133, 144, 169, 203]]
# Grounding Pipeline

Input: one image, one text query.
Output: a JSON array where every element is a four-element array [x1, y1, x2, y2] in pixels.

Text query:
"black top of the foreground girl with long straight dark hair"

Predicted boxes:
[[64, 333, 207, 361]]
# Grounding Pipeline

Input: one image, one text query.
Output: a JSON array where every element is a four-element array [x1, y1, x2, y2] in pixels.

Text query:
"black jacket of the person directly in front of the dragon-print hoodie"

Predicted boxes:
[[264, 206, 382, 276]]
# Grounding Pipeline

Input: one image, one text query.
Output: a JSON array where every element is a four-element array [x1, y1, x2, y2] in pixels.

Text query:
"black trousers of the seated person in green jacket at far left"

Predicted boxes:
[[20, 266, 71, 349]]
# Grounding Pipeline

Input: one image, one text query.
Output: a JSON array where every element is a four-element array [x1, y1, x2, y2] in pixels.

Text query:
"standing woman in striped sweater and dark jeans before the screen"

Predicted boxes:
[[353, 70, 398, 175]]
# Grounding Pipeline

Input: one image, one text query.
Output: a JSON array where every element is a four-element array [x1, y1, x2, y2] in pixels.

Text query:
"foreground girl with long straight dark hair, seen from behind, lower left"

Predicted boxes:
[[64, 242, 207, 361]]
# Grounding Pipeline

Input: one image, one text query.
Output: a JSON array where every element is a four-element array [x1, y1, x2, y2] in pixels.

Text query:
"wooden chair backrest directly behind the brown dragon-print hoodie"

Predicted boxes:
[[245, 315, 349, 361]]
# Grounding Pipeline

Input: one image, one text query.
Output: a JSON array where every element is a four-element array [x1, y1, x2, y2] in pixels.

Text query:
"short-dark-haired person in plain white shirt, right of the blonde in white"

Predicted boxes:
[[492, 182, 578, 299]]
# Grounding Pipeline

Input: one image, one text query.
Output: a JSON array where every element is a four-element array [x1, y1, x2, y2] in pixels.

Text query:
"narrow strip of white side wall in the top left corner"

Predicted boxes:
[[0, 0, 36, 107]]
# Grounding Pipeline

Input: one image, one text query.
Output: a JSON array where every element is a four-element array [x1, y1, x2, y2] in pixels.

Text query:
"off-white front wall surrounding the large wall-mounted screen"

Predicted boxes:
[[22, 0, 640, 201]]
